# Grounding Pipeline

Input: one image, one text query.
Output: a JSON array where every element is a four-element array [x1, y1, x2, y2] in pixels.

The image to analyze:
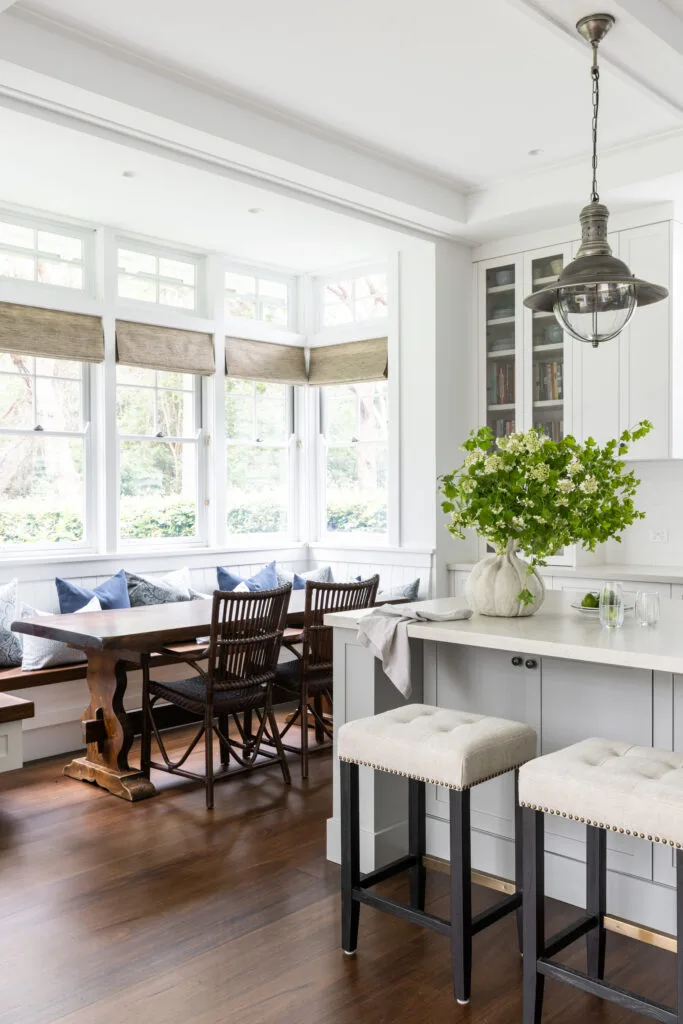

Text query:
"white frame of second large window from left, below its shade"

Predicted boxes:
[[114, 371, 210, 551]]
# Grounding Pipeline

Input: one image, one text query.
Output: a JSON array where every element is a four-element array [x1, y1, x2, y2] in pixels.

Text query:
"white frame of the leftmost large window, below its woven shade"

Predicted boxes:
[[0, 356, 95, 561]]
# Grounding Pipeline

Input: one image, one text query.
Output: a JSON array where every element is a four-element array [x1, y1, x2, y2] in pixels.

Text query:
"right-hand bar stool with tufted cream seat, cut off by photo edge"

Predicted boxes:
[[519, 738, 683, 1024]]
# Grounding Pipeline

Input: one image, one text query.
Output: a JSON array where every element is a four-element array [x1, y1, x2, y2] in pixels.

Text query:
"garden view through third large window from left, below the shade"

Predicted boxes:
[[225, 377, 293, 535]]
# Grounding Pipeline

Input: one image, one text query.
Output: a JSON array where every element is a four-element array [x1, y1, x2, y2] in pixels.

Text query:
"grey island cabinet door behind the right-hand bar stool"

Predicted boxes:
[[542, 658, 652, 879]]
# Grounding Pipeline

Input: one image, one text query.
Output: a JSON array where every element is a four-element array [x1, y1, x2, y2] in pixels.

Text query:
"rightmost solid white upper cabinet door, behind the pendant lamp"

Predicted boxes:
[[618, 222, 672, 459]]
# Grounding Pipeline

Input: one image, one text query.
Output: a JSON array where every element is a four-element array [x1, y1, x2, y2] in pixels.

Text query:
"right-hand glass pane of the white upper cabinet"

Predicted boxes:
[[531, 254, 564, 441]]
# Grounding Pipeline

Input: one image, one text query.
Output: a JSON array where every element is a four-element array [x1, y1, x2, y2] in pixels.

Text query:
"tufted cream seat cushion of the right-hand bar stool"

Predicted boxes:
[[519, 737, 683, 848]]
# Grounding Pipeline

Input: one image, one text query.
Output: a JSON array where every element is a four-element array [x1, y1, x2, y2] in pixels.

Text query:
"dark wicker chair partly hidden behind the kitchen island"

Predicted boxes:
[[275, 575, 380, 778]]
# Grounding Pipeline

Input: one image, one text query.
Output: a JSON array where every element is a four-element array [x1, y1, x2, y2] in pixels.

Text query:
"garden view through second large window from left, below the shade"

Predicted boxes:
[[117, 365, 201, 541]]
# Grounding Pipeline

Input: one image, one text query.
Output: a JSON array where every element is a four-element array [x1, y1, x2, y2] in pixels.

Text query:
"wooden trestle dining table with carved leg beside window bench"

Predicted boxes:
[[11, 590, 305, 801]]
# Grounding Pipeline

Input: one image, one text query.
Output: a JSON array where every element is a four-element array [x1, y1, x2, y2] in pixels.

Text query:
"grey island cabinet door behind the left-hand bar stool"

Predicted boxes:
[[427, 644, 541, 839]]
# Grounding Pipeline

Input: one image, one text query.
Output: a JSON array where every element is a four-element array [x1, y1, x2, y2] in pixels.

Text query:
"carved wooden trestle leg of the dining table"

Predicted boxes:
[[65, 649, 156, 801]]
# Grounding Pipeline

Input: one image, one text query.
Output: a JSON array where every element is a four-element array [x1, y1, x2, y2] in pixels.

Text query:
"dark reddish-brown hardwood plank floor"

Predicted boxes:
[[0, 724, 674, 1024]]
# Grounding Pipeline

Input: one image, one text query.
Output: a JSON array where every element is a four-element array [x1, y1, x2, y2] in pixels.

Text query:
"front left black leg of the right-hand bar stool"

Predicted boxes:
[[522, 807, 546, 1024]]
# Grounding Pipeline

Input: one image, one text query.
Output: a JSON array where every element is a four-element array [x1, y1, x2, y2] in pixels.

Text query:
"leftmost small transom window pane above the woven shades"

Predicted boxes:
[[0, 220, 85, 290]]
